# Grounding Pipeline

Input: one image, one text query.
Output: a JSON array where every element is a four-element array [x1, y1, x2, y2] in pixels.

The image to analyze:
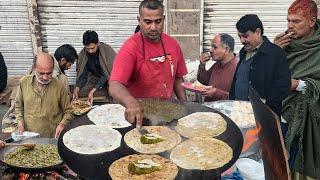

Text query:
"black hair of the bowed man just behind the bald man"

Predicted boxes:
[[54, 44, 78, 63]]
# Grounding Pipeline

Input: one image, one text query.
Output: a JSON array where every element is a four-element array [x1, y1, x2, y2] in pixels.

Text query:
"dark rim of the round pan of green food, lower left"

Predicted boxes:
[[0, 137, 62, 173]]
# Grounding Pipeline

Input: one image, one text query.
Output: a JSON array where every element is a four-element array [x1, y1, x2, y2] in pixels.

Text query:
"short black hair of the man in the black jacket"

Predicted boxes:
[[236, 14, 263, 35]]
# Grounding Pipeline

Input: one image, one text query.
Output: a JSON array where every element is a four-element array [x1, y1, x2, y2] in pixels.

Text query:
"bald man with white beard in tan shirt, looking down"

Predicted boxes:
[[15, 53, 73, 138]]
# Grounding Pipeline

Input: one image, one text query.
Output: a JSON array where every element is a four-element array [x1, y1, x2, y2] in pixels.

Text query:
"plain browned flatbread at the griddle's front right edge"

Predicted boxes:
[[170, 137, 233, 170]]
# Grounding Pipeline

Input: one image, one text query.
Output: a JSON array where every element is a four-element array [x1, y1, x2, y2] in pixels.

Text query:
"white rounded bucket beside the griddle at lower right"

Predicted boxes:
[[236, 158, 265, 180]]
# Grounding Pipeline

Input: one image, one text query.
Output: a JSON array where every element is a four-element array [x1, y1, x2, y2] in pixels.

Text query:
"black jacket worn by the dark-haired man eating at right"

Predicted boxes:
[[229, 37, 291, 116]]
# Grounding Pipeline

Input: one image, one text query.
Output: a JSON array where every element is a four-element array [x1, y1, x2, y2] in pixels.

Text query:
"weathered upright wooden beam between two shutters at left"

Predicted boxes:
[[26, 0, 42, 55]]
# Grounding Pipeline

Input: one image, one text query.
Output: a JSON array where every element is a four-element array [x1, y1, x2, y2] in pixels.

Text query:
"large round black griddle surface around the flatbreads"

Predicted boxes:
[[58, 101, 243, 180]]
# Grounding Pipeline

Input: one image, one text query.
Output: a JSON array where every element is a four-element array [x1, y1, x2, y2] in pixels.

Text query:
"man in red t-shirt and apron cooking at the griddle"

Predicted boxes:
[[109, 0, 187, 127]]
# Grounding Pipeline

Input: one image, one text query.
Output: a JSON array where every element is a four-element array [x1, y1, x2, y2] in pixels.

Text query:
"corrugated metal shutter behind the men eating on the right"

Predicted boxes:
[[204, 0, 293, 54]]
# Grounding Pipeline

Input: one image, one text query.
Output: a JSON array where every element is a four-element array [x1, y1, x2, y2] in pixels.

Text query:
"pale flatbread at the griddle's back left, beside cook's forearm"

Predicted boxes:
[[88, 104, 131, 128]]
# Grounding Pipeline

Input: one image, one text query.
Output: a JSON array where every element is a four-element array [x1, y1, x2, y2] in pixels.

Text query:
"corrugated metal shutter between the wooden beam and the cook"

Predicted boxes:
[[37, 0, 141, 84]]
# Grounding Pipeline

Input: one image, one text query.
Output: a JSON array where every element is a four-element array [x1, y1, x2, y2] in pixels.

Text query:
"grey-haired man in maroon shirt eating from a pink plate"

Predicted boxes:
[[198, 33, 238, 101]]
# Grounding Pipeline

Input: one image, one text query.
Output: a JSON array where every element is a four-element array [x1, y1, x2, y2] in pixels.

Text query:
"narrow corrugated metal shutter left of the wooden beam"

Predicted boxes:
[[0, 0, 33, 76]]
